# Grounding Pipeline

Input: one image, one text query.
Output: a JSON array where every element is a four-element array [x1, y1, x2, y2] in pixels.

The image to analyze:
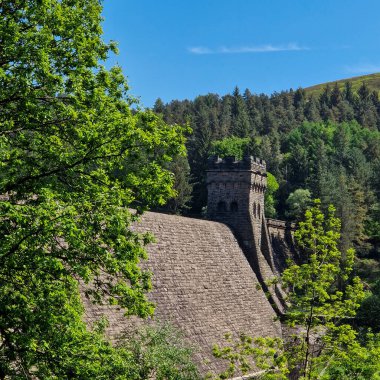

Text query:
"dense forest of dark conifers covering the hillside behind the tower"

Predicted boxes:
[[154, 82, 380, 260]]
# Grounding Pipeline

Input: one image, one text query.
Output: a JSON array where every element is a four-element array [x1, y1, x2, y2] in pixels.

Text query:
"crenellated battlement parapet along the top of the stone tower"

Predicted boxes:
[[207, 156, 267, 176]]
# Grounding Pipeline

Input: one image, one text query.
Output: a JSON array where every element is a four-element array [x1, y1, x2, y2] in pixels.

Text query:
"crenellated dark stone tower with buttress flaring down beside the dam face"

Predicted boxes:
[[207, 156, 284, 313]]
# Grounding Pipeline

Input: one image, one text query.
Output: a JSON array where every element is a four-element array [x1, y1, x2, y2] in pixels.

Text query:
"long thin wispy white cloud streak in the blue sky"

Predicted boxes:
[[187, 43, 309, 55]]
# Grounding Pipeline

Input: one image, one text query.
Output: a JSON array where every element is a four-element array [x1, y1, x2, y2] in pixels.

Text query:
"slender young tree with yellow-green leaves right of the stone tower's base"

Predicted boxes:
[[281, 201, 364, 379]]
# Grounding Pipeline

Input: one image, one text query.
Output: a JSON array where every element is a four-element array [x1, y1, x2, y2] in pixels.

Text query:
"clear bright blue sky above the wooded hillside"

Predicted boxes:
[[103, 0, 380, 107]]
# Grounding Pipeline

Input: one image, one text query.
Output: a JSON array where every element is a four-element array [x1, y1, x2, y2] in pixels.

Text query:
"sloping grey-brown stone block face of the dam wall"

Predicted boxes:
[[83, 213, 281, 373]]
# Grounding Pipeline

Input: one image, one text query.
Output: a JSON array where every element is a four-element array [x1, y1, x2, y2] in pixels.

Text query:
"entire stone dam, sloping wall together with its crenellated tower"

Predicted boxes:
[[83, 157, 292, 374]]
